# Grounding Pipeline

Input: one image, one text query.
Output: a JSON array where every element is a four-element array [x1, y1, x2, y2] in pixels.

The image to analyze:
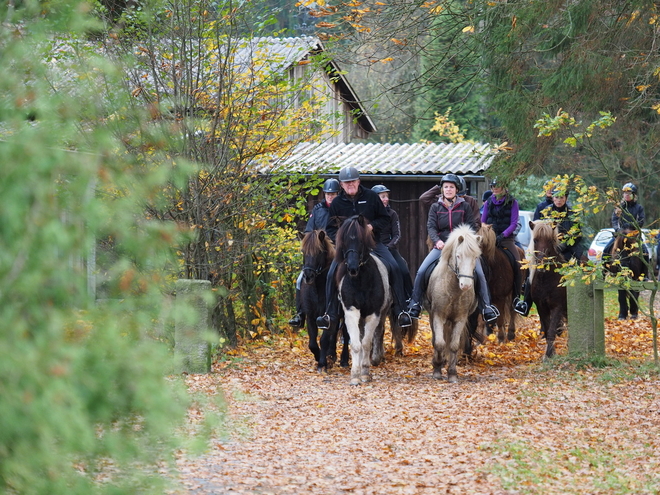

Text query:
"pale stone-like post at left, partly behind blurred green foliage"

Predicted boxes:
[[174, 279, 211, 373]]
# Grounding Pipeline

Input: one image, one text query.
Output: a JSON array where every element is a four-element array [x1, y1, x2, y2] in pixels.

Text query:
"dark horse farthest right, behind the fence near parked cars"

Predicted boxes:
[[603, 229, 649, 320]]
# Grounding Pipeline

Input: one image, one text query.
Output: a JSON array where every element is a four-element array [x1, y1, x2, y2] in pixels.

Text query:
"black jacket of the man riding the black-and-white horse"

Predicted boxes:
[[325, 185, 392, 242]]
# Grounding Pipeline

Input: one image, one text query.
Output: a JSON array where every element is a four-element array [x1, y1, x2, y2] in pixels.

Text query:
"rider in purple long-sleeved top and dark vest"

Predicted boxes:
[[481, 179, 522, 316]]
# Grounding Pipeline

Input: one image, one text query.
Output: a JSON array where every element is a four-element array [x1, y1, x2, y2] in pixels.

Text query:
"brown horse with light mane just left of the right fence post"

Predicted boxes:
[[528, 220, 568, 359]]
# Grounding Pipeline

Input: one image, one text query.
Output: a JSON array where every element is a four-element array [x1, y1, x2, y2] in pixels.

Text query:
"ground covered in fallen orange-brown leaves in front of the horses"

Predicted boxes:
[[176, 318, 660, 495]]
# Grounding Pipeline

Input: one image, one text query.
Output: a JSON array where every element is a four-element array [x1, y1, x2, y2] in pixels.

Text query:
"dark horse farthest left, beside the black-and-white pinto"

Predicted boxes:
[[300, 230, 348, 371]]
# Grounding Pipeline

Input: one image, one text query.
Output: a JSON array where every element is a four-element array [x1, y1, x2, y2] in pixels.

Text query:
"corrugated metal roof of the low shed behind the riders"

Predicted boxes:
[[259, 143, 494, 175]]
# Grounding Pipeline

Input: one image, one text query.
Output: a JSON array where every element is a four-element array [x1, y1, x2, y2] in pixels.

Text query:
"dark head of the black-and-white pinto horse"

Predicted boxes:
[[336, 215, 376, 277]]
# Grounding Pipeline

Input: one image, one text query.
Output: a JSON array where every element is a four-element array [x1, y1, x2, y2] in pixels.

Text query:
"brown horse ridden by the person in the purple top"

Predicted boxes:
[[479, 223, 517, 342]]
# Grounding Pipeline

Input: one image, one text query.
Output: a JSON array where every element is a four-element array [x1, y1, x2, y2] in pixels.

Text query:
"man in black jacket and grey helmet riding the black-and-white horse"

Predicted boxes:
[[316, 167, 412, 329]]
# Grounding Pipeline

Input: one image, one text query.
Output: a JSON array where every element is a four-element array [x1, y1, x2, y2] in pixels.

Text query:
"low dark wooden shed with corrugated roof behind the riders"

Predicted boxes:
[[261, 143, 494, 276]]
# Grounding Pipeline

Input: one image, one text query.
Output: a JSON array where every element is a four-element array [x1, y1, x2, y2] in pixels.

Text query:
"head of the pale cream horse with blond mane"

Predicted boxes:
[[442, 225, 482, 291]]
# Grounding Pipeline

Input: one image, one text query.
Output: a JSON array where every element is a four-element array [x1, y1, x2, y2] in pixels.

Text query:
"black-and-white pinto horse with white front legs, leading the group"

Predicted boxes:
[[335, 215, 392, 385]]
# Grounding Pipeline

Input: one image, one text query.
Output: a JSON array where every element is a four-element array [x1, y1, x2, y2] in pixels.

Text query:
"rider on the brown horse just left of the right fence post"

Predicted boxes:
[[514, 185, 584, 316]]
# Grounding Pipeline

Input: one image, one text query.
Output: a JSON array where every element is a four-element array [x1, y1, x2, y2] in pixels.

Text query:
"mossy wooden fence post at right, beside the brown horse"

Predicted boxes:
[[566, 280, 605, 356]]
